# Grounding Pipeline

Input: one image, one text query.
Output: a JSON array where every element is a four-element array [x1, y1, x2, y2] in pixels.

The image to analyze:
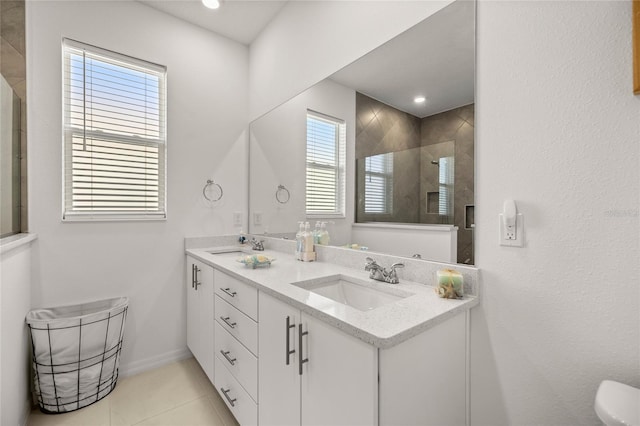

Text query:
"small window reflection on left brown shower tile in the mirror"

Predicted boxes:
[[364, 152, 393, 214]]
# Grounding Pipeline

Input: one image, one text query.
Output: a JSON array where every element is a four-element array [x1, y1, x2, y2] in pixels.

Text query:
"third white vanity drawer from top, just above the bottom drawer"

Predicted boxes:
[[215, 323, 258, 401]]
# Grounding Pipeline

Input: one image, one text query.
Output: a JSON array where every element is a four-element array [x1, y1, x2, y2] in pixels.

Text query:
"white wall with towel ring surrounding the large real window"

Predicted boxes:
[[27, 1, 248, 373]]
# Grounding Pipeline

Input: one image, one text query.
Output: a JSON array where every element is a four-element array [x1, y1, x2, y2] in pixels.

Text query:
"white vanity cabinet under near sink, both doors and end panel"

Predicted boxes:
[[258, 292, 468, 426]]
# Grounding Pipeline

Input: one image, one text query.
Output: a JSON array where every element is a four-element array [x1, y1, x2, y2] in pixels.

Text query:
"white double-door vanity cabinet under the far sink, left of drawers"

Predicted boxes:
[[185, 256, 214, 382]]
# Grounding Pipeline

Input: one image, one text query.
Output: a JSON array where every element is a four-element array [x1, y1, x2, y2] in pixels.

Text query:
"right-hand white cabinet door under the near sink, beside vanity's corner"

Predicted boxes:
[[302, 313, 378, 426]]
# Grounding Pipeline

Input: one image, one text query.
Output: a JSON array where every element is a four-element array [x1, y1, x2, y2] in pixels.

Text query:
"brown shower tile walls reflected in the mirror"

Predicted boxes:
[[356, 92, 474, 263]]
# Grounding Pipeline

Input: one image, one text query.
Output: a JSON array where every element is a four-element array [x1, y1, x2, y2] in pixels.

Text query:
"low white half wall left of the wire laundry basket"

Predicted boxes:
[[0, 235, 31, 425]]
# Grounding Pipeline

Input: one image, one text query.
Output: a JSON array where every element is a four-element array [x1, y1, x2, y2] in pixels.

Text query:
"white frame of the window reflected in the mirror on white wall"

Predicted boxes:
[[305, 109, 347, 219]]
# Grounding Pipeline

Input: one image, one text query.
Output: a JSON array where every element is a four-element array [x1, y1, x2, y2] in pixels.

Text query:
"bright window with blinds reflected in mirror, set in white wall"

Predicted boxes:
[[306, 111, 346, 217]]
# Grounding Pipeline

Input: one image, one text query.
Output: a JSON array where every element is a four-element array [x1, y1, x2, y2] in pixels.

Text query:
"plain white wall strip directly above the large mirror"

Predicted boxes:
[[249, 0, 452, 120]]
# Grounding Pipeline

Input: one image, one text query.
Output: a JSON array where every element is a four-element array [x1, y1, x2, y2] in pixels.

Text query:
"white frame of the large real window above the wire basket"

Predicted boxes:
[[61, 38, 167, 222]]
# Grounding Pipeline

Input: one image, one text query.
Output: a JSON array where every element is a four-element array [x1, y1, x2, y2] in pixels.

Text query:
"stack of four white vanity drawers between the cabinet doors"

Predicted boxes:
[[213, 270, 258, 426]]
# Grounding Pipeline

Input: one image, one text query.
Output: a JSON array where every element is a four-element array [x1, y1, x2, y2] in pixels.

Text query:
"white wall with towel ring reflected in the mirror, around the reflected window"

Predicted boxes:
[[249, 80, 356, 241]]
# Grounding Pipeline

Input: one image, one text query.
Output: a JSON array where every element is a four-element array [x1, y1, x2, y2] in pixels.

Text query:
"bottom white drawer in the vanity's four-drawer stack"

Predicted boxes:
[[215, 357, 258, 426]]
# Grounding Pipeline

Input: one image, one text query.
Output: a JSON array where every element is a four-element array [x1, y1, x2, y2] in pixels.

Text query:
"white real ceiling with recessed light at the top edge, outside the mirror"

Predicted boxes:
[[138, 0, 286, 45]]
